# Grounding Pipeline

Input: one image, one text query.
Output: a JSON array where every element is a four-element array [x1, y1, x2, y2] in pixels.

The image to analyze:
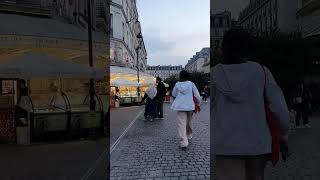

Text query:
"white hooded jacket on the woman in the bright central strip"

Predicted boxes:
[[171, 81, 201, 111]]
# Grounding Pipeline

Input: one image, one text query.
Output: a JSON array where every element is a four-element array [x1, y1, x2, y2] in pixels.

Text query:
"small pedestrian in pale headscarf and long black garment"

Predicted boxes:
[[142, 84, 157, 121]]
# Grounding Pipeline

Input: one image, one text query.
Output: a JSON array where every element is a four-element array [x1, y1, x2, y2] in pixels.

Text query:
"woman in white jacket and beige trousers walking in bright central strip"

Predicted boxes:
[[171, 71, 201, 148]]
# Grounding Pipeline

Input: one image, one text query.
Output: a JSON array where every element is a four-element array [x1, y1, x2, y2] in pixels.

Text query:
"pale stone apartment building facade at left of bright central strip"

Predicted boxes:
[[110, 0, 147, 72]]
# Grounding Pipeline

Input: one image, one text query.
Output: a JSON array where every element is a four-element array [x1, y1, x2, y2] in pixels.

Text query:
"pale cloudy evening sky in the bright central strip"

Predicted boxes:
[[137, 0, 210, 66]]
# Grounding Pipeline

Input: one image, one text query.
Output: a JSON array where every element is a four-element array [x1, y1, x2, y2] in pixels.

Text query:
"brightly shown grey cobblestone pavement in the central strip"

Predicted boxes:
[[110, 103, 210, 180]]
